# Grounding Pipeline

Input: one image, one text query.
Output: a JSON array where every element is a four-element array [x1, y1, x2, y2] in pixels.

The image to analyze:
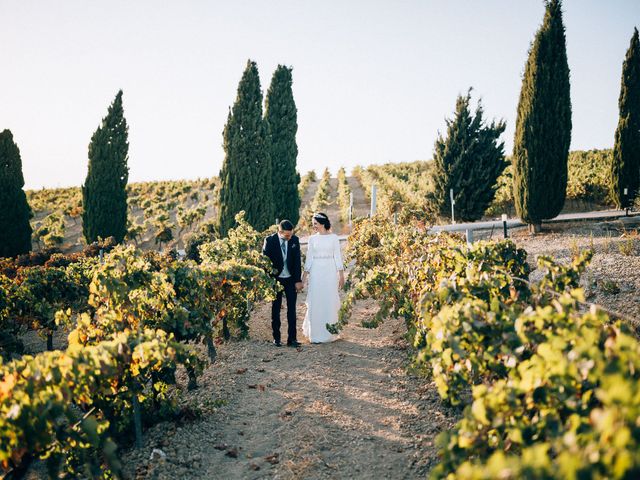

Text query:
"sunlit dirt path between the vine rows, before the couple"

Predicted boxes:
[[124, 298, 454, 479]]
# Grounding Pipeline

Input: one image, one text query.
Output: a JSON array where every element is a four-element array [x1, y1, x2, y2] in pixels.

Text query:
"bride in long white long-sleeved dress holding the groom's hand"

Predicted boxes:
[[302, 213, 344, 343]]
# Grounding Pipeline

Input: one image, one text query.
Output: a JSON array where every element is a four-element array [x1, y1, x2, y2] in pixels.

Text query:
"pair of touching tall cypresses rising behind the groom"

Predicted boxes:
[[218, 60, 300, 235]]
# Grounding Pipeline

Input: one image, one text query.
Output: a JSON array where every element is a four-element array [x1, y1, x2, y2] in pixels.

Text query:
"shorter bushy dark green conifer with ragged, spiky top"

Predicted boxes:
[[427, 90, 507, 221]]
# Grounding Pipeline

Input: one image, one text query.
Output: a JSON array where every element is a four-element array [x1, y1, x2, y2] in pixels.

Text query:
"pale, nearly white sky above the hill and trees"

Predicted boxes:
[[0, 0, 640, 188]]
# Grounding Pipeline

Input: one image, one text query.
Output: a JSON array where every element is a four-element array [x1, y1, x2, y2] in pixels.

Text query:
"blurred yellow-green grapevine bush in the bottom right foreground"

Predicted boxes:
[[432, 300, 640, 479]]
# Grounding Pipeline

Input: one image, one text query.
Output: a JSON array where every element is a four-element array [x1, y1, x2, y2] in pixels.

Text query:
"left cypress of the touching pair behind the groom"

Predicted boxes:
[[218, 60, 275, 235]]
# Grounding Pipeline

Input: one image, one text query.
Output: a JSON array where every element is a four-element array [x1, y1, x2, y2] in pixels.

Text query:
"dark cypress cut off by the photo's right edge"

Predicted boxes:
[[610, 28, 640, 208]]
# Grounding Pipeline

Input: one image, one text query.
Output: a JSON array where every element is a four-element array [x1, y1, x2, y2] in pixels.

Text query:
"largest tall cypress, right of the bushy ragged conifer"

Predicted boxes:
[[513, 0, 571, 231]]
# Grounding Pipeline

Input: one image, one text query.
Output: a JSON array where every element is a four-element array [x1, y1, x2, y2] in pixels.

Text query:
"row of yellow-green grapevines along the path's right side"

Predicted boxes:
[[341, 218, 640, 479]]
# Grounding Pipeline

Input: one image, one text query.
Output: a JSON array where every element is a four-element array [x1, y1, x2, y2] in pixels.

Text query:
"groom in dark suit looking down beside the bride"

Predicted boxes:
[[262, 220, 302, 347]]
